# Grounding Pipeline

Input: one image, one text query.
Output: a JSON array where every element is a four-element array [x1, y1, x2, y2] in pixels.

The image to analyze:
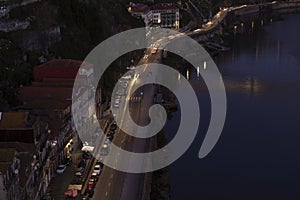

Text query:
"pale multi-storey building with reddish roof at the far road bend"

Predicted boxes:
[[128, 3, 179, 29]]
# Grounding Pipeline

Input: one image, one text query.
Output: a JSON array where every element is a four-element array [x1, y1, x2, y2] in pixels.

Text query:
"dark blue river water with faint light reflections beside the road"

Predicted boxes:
[[165, 14, 300, 200]]
